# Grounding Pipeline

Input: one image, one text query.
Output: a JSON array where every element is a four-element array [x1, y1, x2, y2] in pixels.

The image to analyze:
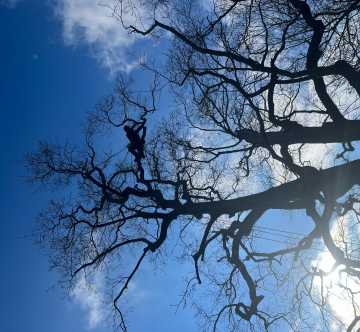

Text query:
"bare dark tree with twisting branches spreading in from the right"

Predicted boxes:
[[28, 0, 360, 331]]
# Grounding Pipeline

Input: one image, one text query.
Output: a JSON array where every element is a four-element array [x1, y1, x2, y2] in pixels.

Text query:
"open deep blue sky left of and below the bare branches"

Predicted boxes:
[[0, 0, 197, 332]]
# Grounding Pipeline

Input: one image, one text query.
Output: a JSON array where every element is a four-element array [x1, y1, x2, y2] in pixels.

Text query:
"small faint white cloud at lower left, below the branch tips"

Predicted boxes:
[[71, 274, 106, 328]]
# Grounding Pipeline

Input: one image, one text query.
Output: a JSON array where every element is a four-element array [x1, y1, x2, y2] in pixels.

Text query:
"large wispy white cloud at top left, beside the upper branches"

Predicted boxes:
[[56, 0, 138, 72]]
